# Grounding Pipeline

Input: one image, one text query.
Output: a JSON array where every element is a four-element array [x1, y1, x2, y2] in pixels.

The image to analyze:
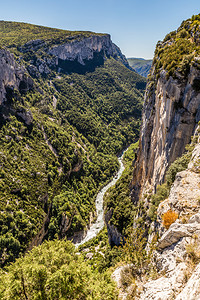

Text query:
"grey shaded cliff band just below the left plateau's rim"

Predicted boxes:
[[48, 34, 132, 72]]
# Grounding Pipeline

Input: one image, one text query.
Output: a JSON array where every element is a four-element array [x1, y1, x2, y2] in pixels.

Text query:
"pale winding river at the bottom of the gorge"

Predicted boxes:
[[75, 150, 126, 247]]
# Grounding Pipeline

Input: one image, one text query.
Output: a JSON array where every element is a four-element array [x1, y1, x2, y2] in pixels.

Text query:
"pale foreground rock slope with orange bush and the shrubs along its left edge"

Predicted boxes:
[[113, 126, 200, 300]]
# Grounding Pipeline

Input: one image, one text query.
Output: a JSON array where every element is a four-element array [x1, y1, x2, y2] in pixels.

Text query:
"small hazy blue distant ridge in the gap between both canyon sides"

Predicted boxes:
[[127, 57, 152, 77]]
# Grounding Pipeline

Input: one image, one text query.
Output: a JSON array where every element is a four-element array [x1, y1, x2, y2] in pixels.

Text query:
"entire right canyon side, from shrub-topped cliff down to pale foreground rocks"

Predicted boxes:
[[108, 15, 200, 300]]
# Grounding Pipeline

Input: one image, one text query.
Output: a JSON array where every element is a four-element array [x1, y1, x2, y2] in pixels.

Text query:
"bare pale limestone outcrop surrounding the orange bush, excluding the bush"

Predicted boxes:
[[139, 131, 200, 300]]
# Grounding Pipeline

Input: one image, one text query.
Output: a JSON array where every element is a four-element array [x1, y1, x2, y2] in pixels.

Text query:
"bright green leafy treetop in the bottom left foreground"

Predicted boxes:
[[0, 240, 117, 300]]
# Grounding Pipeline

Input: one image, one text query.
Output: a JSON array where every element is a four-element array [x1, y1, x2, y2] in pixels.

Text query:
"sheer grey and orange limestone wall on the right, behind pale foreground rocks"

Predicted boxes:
[[132, 19, 200, 201]]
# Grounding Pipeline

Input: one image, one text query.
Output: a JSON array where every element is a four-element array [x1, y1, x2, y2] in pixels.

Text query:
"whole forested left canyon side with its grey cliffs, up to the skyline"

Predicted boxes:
[[0, 21, 146, 265]]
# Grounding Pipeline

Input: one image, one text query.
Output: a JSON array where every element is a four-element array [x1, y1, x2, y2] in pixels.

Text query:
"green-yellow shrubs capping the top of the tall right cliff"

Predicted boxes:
[[153, 15, 200, 79]]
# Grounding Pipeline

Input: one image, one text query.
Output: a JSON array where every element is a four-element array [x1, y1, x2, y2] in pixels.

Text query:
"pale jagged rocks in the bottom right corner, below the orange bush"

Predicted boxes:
[[138, 214, 200, 300]]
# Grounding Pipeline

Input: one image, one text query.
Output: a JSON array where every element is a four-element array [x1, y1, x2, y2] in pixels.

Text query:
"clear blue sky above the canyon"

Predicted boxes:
[[0, 0, 200, 58]]
